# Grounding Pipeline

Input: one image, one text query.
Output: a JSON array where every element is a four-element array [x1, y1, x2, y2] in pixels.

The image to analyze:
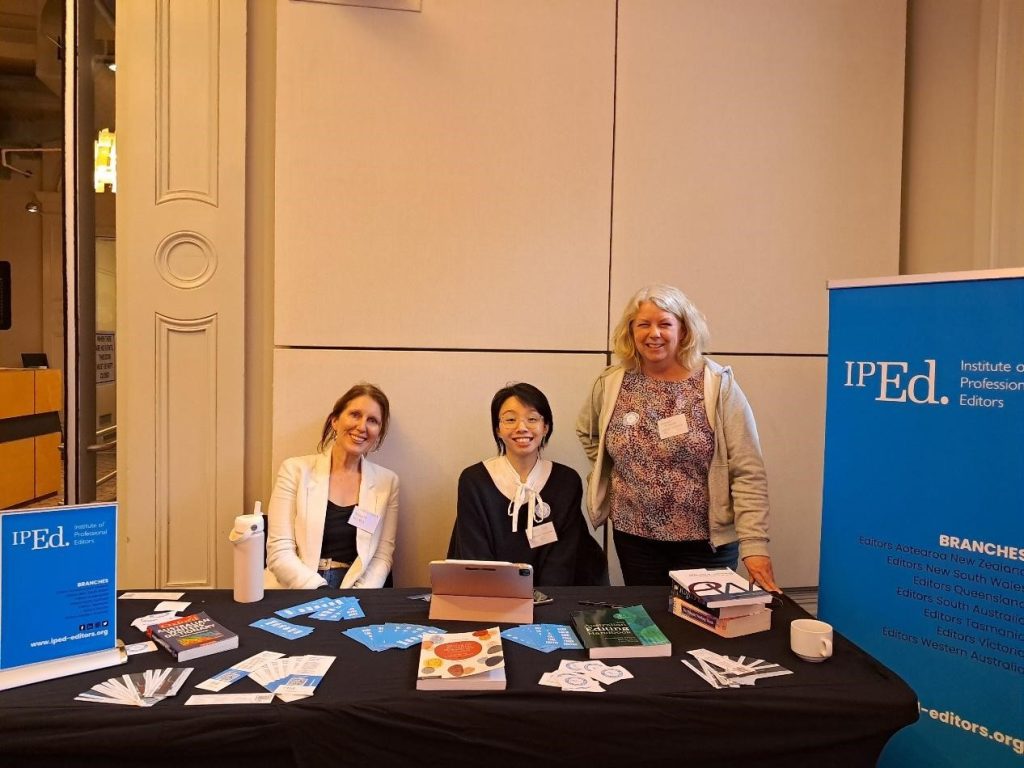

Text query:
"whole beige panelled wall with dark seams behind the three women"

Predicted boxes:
[[263, 0, 905, 586]]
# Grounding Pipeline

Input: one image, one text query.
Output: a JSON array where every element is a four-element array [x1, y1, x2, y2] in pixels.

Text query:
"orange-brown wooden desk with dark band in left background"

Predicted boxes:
[[0, 369, 63, 509]]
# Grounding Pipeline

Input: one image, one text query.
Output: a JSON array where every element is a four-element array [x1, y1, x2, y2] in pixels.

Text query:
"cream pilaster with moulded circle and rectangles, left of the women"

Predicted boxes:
[[117, 0, 247, 588]]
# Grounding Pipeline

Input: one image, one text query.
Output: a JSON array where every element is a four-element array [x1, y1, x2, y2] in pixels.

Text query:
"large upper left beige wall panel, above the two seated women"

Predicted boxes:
[[274, 0, 614, 350]]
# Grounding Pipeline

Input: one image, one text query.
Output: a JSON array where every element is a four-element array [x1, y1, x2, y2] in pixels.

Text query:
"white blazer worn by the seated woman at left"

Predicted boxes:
[[263, 449, 398, 589]]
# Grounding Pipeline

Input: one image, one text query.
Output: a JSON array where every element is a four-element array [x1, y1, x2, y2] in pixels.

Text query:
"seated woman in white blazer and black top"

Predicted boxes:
[[264, 384, 398, 589]]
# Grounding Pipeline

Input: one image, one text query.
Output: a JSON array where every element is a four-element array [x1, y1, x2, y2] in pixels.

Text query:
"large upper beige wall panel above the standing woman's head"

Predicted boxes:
[[610, 0, 905, 353]]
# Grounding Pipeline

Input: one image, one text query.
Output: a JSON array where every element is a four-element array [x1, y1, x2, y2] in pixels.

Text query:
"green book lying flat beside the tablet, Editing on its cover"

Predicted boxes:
[[569, 605, 672, 658]]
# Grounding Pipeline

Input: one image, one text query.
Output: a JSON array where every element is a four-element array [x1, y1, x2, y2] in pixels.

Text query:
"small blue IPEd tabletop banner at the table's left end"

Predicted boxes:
[[0, 504, 117, 671]]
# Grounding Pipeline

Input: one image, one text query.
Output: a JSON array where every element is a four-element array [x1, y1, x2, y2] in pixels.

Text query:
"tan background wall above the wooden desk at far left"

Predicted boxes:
[[0, 155, 43, 368]]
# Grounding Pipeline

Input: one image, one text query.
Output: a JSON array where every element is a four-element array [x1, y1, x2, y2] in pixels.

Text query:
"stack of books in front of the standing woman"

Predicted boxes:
[[669, 568, 772, 637]]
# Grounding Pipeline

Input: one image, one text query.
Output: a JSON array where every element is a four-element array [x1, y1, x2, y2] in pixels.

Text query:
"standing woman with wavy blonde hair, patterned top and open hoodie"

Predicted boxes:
[[577, 286, 778, 591]]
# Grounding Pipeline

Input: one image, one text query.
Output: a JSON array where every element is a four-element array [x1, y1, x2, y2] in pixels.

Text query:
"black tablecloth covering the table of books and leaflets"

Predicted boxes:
[[0, 587, 918, 768]]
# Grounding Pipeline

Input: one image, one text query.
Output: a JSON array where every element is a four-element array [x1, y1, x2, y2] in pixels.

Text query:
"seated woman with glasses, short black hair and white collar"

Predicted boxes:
[[447, 384, 604, 587]]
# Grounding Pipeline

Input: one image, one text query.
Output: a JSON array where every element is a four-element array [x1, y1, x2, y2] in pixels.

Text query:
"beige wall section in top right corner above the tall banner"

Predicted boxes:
[[900, 0, 1024, 273]]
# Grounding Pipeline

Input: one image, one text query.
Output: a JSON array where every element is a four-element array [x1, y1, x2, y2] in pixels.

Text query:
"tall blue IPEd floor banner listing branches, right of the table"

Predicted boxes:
[[819, 270, 1024, 768]]
